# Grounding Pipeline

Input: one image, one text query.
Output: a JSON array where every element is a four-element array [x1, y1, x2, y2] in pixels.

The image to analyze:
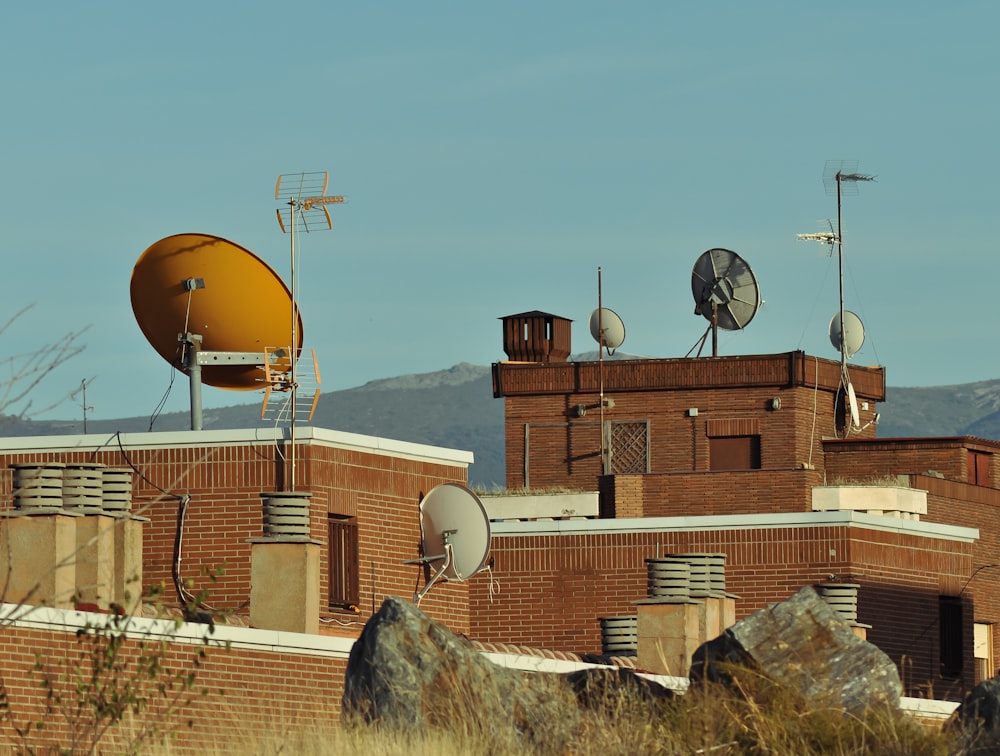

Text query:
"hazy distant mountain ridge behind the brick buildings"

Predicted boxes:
[[0, 362, 1000, 488]]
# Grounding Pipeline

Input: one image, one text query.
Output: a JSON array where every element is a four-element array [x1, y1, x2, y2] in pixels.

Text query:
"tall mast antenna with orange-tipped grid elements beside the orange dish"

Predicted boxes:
[[274, 171, 344, 491]]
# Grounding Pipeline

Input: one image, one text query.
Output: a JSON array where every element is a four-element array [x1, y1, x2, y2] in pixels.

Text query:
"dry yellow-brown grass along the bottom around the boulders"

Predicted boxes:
[[148, 671, 961, 756]]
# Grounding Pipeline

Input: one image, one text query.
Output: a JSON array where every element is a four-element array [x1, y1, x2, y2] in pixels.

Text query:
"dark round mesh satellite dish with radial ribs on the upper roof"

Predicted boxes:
[[685, 247, 762, 357]]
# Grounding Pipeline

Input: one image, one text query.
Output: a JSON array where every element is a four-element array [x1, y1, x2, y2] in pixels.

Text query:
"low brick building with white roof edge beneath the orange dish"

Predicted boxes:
[[0, 428, 472, 635]]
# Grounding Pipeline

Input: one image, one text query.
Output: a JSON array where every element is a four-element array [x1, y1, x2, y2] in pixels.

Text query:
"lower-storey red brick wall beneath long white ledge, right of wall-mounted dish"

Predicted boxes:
[[469, 523, 972, 690]]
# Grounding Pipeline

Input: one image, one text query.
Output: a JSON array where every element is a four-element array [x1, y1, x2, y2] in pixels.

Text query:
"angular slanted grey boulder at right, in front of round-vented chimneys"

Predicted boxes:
[[690, 586, 902, 714]]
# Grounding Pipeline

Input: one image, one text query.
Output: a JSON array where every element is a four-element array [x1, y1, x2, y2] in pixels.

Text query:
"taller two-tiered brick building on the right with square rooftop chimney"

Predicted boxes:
[[480, 311, 1000, 697]]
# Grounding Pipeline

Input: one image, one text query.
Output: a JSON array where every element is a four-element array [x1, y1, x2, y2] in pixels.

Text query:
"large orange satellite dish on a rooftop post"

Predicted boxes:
[[131, 234, 302, 391]]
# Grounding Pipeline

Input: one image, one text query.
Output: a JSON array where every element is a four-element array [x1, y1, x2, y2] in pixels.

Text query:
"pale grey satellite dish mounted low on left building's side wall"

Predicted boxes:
[[404, 483, 490, 604]]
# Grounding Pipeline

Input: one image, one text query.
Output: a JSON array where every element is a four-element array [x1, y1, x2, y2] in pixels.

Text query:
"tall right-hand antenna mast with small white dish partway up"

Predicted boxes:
[[798, 160, 875, 435]]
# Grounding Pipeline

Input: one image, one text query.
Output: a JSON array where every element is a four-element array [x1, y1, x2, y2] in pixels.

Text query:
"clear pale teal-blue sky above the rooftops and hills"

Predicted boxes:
[[0, 0, 1000, 426]]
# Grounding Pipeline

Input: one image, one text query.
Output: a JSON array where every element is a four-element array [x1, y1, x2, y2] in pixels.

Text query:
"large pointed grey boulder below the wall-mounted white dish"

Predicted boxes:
[[342, 597, 580, 750]]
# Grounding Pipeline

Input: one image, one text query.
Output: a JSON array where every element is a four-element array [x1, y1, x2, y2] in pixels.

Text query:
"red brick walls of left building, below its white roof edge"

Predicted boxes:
[[0, 434, 468, 633]]
